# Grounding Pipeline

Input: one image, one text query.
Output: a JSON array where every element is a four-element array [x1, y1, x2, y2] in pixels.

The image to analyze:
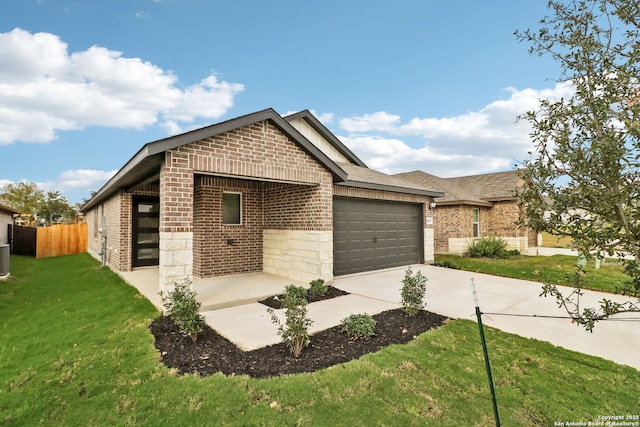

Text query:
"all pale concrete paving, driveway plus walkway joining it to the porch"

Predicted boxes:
[[203, 265, 640, 370]]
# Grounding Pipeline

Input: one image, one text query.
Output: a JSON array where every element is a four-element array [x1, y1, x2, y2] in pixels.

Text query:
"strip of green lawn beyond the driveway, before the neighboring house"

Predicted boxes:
[[435, 254, 629, 293]]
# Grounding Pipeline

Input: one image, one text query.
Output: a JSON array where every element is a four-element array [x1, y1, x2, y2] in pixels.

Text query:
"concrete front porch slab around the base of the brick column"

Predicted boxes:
[[117, 267, 308, 311]]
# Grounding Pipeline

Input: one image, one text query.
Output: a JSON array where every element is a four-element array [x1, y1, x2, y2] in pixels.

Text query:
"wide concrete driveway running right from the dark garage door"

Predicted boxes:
[[333, 265, 640, 370]]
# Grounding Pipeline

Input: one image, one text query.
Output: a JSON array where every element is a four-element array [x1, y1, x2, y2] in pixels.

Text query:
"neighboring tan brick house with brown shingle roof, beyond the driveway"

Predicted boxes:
[[394, 171, 538, 254]]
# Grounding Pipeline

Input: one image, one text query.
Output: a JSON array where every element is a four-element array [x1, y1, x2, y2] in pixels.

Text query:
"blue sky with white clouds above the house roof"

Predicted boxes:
[[0, 0, 567, 207]]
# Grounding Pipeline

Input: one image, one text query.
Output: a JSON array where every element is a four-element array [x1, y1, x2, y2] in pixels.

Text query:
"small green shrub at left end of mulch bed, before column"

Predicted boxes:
[[160, 278, 205, 342]]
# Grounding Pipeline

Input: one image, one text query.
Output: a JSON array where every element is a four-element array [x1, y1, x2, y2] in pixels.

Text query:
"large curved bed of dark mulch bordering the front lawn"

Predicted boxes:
[[150, 309, 446, 378]]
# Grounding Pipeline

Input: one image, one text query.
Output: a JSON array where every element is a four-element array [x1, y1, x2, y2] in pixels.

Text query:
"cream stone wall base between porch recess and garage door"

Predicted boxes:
[[263, 230, 333, 283]]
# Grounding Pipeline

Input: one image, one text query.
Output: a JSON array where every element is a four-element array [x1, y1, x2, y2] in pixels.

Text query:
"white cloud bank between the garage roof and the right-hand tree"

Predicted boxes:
[[340, 83, 572, 177]]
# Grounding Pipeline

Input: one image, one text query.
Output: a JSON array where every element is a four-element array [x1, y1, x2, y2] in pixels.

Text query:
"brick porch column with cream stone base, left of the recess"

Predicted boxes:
[[159, 152, 193, 291]]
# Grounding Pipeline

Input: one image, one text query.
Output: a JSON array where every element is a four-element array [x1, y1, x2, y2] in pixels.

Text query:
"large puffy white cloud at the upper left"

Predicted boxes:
[[0, 28, 244, 144]]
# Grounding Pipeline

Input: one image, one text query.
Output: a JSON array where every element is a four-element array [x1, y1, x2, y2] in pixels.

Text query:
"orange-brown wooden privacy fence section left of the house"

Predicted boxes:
[[36, 222, 88, 258]]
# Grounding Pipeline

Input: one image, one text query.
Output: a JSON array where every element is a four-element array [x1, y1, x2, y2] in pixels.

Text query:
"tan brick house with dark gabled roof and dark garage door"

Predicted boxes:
[[82, 109, 443, 290]]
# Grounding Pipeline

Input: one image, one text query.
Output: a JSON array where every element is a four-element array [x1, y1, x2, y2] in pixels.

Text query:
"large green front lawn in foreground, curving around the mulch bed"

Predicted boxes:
[[0, 254, 640, 426]]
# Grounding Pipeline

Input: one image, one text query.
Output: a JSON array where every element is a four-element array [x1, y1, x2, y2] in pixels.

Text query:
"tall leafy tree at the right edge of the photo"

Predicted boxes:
[[516, 0, 640, 330]]
